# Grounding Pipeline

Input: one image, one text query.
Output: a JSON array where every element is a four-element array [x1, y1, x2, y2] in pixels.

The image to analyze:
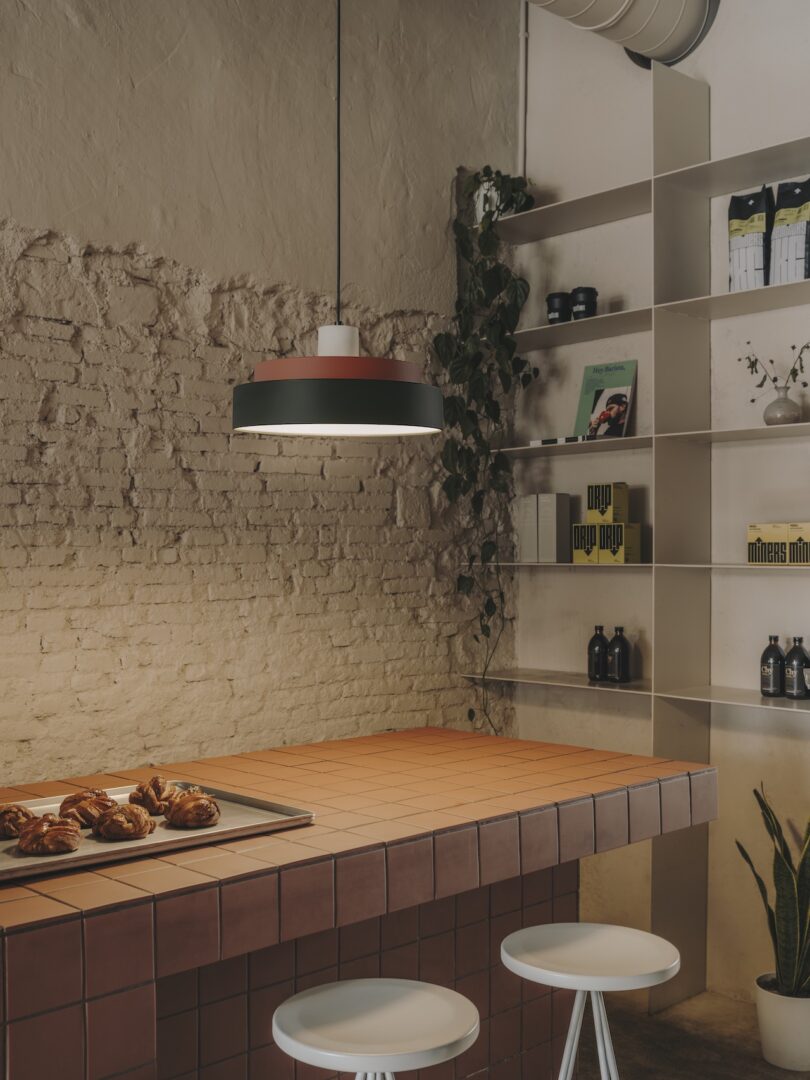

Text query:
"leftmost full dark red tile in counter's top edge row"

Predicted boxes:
[[5, 918, 82, 1020]]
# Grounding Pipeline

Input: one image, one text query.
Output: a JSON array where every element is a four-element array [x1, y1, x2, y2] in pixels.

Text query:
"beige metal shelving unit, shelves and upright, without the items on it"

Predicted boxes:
[[470, 64, 810, 1008]]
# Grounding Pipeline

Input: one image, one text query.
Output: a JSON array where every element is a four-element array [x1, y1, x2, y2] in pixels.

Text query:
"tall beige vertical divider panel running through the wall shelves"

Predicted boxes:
[[648, 63, 712, 1012]]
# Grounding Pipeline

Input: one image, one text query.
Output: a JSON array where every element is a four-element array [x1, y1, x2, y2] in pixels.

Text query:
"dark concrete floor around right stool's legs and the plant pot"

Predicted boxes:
[[579, 994, 810, 1080]]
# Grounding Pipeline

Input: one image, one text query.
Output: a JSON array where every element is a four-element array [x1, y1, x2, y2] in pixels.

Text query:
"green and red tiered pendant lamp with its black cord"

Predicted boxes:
[[233, 0, 443, 438]]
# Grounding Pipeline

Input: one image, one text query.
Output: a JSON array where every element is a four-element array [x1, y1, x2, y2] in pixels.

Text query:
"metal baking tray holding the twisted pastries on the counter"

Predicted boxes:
[[0, 780, 313, 881]]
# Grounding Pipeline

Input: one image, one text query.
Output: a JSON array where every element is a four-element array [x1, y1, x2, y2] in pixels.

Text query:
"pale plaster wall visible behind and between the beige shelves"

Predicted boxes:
[[517, 0, 810, 998]]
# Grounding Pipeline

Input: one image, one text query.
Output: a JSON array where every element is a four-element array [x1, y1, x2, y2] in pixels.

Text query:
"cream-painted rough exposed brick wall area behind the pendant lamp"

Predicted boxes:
[[0, 222, 510, 784]]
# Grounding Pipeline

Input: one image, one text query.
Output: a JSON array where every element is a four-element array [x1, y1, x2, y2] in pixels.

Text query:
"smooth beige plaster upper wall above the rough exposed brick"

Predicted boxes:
[[0, 0, 517, 311]]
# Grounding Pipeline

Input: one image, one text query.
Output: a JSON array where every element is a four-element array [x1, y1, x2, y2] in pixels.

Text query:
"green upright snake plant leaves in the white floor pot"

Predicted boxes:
[[735, 788, 810, 998]]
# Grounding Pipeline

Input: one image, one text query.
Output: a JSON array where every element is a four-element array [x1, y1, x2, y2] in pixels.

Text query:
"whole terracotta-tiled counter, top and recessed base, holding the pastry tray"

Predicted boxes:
[[0, 729, 716, 1080]]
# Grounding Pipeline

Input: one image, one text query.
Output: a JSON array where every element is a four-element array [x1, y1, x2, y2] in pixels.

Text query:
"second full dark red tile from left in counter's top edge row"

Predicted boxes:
[[84, 901, 154, 998]]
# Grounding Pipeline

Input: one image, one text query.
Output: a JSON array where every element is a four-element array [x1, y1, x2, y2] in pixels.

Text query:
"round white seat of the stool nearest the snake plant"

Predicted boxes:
[[501, 922, 680, 990]]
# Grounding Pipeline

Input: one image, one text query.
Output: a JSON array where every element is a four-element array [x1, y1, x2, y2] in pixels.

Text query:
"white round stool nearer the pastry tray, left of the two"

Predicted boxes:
[[273, 978, 480, 1080]]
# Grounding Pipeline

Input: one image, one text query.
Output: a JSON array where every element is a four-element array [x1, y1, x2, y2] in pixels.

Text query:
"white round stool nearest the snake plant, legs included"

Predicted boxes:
[[501, 922, 680, 1080]]
